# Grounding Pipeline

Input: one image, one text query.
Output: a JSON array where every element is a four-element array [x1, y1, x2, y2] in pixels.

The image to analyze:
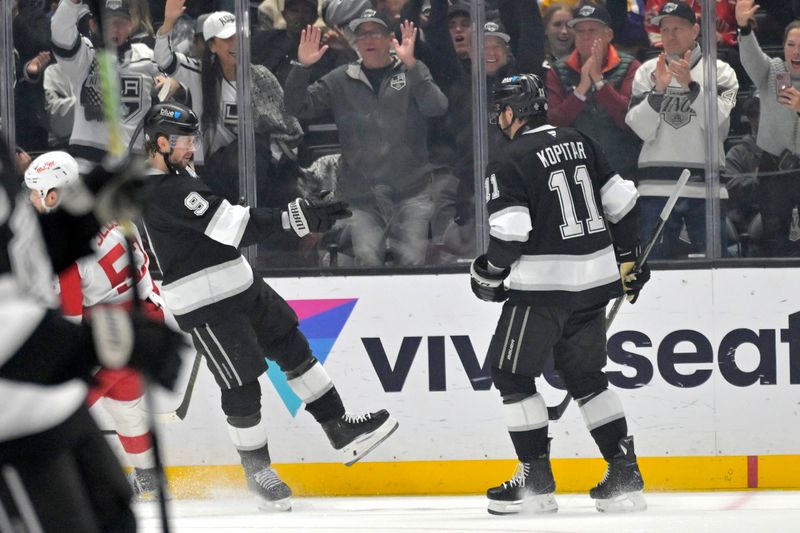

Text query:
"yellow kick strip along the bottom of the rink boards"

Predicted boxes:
[[162, 455, 800, 498]]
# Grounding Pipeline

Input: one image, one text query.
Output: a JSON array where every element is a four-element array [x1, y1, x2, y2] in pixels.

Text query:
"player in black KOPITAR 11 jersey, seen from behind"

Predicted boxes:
[[471, 74, 650, 514]]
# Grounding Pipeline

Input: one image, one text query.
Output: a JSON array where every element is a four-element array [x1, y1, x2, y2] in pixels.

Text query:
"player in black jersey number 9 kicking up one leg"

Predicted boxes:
[[138, 104, 398, 510]]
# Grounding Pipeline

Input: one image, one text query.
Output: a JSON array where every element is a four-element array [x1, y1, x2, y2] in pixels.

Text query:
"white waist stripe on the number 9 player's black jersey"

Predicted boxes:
[[162, 257, 253, 315]]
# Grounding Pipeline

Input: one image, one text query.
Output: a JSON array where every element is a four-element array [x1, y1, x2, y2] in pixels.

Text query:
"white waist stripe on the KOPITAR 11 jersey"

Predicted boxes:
[[508, 245, 619, 292]]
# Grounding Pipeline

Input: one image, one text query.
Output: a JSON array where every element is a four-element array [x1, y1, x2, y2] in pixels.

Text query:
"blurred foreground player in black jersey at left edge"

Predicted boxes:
[[0, 139, 184, 533]]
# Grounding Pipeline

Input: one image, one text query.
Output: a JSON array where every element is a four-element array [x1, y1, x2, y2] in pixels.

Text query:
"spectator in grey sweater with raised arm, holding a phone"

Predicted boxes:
[[736, 0, 800, 257]]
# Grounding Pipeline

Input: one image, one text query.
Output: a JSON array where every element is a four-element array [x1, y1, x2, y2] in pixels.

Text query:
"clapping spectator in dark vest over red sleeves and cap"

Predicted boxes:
[[546, 5, 641, 178]]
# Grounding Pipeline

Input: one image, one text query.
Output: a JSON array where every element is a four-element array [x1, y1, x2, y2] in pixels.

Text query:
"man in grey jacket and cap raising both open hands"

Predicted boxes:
[[285, 9, 447, 266]]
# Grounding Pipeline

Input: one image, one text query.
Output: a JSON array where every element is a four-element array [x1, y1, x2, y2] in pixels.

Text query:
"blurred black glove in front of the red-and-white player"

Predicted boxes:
[[89, 306, 187, 389]]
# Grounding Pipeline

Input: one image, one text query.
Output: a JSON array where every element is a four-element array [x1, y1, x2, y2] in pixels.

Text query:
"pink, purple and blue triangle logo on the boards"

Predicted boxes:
[[267, 298, 358, 416]]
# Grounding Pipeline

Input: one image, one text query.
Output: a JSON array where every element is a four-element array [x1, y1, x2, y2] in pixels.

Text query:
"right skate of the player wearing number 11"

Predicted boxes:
[[589, 436, 647, 513]]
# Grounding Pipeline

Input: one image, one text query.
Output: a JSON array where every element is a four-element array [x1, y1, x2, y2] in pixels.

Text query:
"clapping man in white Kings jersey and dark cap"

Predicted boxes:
[[626, 2, 739, 259]]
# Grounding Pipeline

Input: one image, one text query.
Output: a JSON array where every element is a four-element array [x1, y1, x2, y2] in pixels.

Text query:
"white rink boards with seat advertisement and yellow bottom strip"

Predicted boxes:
[[99, 269, 800, 495]]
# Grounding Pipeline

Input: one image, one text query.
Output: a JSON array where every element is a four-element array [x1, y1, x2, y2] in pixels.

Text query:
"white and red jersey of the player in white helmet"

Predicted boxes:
[[58, 222, 156, 320]]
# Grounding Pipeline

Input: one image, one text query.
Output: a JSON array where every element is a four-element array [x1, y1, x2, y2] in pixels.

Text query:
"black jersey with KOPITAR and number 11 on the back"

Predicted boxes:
[[484, 125, 638, 308]]
